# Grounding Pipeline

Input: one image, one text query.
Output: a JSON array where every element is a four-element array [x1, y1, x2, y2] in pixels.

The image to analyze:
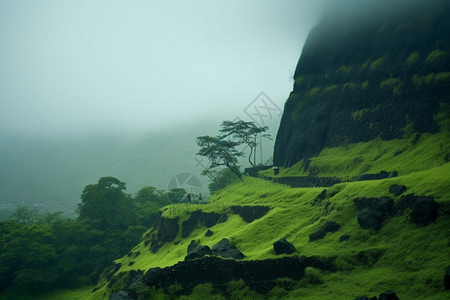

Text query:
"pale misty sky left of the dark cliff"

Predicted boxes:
[[0, 0, 324, 136]]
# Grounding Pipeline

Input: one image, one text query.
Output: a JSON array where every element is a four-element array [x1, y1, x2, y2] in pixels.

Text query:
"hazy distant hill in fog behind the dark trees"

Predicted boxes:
[[0, 128, 208, 218]]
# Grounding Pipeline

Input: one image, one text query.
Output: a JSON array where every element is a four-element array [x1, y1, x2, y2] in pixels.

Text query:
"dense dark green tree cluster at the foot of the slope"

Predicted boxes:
[[0, 177, 168, 293]]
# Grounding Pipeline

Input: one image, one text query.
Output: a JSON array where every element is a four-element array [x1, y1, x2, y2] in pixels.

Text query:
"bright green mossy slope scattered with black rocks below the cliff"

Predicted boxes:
[[42, 134, 450, 299]]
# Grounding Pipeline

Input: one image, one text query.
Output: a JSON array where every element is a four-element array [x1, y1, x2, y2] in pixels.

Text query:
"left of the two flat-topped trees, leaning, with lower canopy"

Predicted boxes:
[[197, 135, 244, 179]]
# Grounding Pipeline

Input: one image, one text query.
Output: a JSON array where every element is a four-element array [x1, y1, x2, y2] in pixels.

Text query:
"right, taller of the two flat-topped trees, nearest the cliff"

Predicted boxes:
[[219, 120, 270, 167]]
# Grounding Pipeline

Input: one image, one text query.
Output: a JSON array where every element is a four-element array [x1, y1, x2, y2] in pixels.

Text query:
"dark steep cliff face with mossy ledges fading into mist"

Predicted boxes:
[[274, 1, 450, 167]]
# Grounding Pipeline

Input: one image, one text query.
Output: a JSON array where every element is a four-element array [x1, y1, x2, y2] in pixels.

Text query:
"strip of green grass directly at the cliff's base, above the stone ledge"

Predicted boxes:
[[272, 132, 450, 178]]
